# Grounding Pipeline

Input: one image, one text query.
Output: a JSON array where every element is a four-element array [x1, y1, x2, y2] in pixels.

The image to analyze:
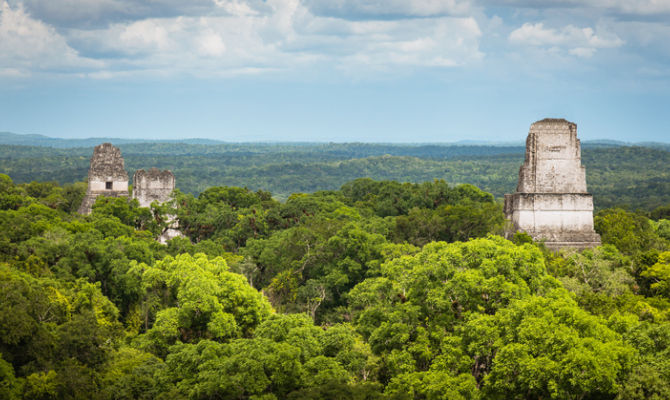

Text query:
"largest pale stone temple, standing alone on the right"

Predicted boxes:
[[505, 118, 600, 250]]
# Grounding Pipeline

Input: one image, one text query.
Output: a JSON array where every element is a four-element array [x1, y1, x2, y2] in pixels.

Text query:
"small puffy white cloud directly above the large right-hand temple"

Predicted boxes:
[[509, 22, 624, 57]]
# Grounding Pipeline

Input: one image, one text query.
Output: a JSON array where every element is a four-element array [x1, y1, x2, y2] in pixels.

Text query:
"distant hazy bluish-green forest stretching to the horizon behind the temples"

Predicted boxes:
[[0, 142, 670, 211]]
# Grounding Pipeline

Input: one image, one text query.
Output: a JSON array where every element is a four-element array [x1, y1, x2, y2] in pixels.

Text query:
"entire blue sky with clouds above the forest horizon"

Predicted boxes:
[[0, 0, 670, 142]]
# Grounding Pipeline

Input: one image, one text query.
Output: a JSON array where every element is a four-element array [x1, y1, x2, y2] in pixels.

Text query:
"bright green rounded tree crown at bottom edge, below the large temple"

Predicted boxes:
[[476, 291, 636, 398]]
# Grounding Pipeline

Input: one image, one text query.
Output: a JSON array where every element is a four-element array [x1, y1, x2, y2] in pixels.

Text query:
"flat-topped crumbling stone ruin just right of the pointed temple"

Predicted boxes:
[[133, 168, 181, 244]]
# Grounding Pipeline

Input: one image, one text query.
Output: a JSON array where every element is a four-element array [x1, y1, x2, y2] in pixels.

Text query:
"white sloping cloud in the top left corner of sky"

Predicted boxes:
[[0, 1, 102, 72]]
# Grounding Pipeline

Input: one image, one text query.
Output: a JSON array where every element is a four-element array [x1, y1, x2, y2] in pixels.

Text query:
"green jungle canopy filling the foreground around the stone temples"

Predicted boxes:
[[0, 174, 670, 400]]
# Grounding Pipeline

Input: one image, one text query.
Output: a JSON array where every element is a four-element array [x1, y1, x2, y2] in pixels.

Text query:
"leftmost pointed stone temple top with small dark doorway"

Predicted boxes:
[[79, 143, 128, 214]]
